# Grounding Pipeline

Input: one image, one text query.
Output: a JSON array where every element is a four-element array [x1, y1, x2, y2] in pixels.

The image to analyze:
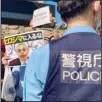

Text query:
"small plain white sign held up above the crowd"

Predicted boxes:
[[33, 6, 50, 27]]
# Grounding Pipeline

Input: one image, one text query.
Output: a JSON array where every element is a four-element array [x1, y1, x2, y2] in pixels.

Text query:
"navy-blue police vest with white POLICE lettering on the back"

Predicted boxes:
[[42, 32, 101, 101]]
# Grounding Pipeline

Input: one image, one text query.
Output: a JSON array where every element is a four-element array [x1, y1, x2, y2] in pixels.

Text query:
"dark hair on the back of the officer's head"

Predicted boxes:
[[57, 0, 93, 19]]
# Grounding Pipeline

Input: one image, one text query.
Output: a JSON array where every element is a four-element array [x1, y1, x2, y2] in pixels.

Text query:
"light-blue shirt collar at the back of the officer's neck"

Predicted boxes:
[[64, 26, 97, 35]]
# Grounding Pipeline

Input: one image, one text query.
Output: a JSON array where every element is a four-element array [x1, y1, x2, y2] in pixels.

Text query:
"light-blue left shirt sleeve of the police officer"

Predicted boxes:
[[23, 44, 49, 101]]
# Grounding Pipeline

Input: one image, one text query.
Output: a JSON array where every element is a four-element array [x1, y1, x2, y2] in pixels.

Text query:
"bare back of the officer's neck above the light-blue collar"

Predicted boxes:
[[68, 17, 95, 29]]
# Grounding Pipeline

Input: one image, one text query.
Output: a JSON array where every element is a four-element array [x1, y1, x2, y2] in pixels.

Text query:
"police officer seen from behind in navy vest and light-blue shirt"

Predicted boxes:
[[23, 0, 101, 102]]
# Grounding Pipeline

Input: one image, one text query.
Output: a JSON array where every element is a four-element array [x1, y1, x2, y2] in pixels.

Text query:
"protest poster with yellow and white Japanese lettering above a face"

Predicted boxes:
[[4, 30, 44, 66]]
